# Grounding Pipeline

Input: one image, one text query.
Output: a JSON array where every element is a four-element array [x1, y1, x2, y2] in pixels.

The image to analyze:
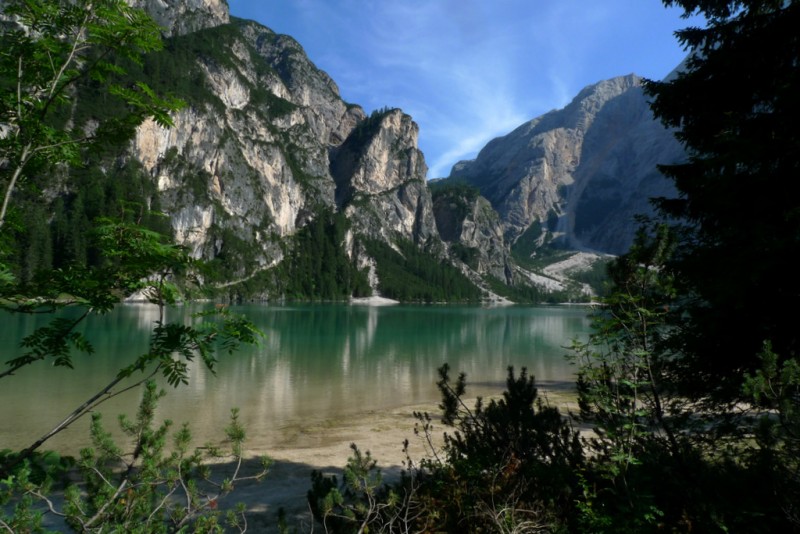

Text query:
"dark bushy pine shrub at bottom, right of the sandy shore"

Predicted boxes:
[[428, 365, 583, 532]]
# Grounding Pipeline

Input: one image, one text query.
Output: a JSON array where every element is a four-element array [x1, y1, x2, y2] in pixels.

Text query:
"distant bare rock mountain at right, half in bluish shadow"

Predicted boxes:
[[450, 75, 683, 253]]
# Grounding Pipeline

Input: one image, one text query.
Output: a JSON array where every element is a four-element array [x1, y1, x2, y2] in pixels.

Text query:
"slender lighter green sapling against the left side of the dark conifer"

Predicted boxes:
[[573, 225, 675, 450]]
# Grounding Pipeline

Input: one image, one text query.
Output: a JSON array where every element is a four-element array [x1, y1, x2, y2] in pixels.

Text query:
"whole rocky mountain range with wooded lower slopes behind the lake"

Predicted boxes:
[[7, 0, 682, 301]]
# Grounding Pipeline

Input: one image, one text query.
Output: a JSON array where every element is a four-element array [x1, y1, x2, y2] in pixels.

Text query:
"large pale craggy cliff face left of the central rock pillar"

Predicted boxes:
[[132, 17, 364, 275]]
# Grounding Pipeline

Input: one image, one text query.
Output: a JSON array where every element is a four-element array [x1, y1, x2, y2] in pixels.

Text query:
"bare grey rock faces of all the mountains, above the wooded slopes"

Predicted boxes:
[[119, 4, 682, 298]]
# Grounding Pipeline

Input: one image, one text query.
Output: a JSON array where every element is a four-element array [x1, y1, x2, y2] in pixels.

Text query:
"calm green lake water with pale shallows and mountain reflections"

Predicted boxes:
[[0, 304, 588, 453]]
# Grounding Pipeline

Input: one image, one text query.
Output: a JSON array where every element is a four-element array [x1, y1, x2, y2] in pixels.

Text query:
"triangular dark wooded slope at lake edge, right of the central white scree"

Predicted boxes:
[[364, 240, 482, 302]]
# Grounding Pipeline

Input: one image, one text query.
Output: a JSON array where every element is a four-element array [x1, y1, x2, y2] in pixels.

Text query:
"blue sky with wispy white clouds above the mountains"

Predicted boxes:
[[229, 0, 697, 178]]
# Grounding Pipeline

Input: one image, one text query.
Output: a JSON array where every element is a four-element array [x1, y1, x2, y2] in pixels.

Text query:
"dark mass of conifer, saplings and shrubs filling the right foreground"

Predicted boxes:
[[310, 0, 800, 533]]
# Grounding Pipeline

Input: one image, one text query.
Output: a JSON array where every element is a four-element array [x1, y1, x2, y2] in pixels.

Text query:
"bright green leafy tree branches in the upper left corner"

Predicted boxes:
[[0, 0, 180, 234]]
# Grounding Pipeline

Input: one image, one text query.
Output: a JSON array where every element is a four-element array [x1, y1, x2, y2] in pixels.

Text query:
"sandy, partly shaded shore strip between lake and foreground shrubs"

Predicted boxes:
[[31, 388, 577, 533]]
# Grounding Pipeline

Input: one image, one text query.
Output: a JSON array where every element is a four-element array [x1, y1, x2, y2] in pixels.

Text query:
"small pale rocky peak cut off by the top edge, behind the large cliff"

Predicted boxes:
[[128, 0, 230, 36]]
